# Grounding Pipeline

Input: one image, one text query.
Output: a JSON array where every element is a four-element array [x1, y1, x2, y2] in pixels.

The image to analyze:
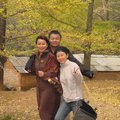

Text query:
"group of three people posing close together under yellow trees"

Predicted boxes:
[[26, 30, 93, 120]]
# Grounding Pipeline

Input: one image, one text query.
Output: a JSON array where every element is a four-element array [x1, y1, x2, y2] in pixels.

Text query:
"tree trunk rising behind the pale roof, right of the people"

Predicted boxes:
[[84, 0, 94, 70]]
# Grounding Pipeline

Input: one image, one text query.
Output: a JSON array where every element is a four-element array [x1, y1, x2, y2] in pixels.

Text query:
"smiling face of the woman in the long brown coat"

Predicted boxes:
[[36, 39, 48, 53]]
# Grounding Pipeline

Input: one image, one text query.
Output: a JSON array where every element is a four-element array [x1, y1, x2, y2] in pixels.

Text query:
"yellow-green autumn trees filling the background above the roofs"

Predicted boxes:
[[0, 0, 120, 75]]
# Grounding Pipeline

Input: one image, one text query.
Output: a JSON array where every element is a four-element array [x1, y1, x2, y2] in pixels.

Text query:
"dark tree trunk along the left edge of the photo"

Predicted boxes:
[[0, 1, 6, 86]]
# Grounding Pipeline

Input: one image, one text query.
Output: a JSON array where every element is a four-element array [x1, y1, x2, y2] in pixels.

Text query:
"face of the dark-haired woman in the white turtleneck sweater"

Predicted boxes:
[[56, 51, 68, 63]]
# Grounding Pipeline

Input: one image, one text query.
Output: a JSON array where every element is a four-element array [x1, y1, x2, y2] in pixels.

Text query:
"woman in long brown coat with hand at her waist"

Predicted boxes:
[[32, 36, 60, 120]]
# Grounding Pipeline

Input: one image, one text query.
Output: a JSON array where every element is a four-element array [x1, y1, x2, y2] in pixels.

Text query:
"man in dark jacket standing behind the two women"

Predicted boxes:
[[48, 30, 94, 78]]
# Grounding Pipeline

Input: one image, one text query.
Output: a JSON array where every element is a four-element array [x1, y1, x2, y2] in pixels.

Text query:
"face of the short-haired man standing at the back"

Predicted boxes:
[[49, 34, 61, 47]]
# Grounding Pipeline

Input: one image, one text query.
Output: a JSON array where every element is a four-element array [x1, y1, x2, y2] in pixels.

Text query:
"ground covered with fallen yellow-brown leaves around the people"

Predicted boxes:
[[0, 80, 120, 120]]
